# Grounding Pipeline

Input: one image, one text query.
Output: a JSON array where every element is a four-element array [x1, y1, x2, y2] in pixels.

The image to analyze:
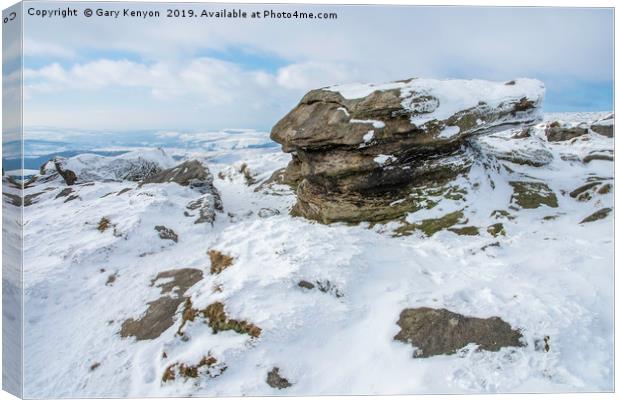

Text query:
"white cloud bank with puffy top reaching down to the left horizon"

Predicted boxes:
[[24, 57, 359, 129]]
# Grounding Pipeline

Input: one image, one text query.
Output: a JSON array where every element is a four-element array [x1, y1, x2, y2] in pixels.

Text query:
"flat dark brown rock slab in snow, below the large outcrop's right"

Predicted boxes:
[[394, 307, 524, 357]]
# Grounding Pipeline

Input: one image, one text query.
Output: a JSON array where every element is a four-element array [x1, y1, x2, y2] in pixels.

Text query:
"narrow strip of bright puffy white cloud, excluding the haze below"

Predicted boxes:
[[24, 57, 361, 105]]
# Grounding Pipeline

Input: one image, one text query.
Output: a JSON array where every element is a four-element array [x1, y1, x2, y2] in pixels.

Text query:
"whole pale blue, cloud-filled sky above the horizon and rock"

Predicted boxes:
[[13, 2, 613, 130]]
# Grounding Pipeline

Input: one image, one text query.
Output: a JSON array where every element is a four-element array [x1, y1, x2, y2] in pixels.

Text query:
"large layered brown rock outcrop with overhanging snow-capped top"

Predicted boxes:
[[271, 79, 544, 223]]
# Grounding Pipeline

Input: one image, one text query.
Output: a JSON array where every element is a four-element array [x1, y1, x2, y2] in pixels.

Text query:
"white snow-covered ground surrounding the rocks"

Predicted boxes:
[[15, 114, 613, 397]]
